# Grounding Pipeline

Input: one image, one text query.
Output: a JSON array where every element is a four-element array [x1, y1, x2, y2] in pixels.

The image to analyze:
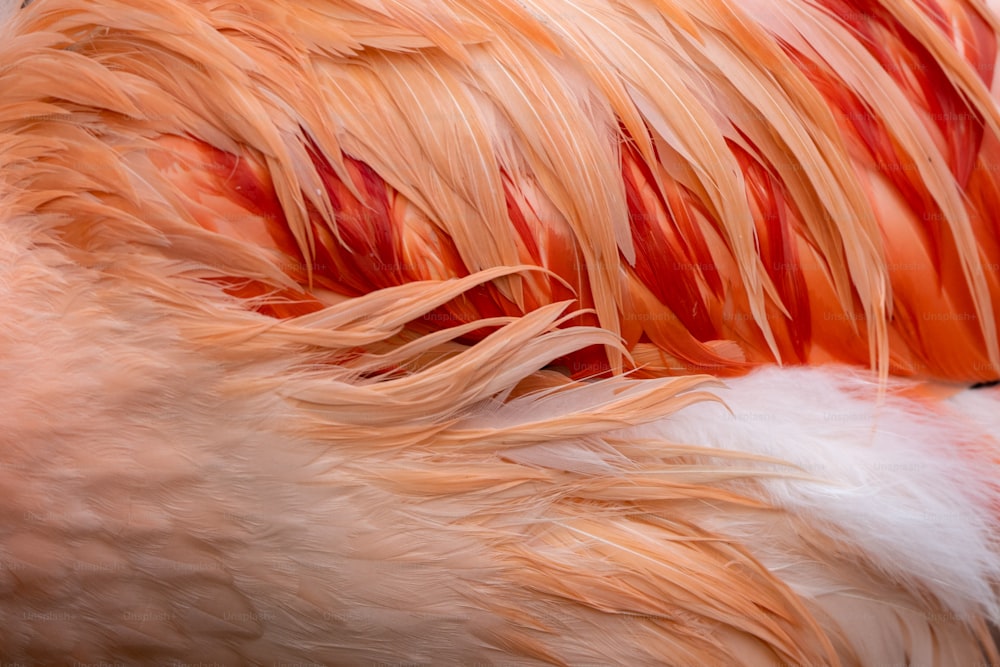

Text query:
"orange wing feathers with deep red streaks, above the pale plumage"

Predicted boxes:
[[8, 0, 1000, 382]]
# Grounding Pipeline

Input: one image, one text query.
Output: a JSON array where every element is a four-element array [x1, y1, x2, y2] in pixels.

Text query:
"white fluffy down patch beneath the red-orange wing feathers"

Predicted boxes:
[[632, 367, 1000, 619]]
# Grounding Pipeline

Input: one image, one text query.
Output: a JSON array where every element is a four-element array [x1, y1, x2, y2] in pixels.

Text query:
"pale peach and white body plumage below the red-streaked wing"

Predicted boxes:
[[0, 214, 1000, 665]]
